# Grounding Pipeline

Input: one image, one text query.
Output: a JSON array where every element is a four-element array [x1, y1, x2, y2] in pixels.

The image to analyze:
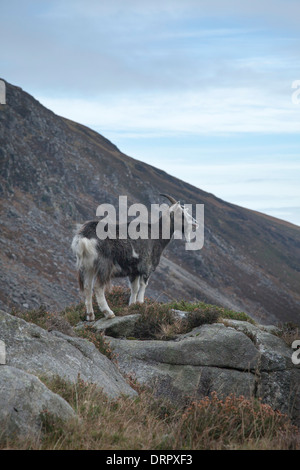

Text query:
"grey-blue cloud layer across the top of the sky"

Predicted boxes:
[[0, 0, 299, 97]]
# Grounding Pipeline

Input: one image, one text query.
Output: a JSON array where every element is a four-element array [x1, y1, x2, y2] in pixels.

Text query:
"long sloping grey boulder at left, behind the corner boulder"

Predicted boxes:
[[0, 310, 136, 398]]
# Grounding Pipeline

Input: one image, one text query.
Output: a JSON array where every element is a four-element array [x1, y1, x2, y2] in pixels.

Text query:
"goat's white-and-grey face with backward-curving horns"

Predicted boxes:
[[161, 194, 199, 242]]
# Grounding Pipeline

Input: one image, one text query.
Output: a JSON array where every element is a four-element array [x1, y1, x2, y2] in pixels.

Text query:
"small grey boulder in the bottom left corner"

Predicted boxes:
[[0, 366, 76, 439]]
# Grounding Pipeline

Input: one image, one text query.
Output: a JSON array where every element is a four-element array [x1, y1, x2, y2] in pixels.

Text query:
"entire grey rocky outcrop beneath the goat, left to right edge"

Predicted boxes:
[[0, 311, 300, 438]]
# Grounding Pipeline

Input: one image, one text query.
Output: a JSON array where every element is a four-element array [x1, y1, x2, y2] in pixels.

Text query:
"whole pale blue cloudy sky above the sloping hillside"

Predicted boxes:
[[0, 0, 300, 225]]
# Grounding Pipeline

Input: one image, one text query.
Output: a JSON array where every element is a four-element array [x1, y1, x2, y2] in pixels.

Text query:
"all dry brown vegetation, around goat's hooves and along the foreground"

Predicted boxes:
[[5, 287, 300, 450]]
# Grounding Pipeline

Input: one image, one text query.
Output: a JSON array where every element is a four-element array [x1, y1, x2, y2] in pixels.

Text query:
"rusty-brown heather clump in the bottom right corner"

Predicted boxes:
[[176, 392, 297, 449]]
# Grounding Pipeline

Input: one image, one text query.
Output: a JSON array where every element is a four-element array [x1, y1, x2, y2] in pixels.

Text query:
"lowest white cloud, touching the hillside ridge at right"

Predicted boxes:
[[139, 155, 300, 225]]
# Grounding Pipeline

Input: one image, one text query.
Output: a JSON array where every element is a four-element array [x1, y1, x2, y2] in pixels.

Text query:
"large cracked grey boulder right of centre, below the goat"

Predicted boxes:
[[107, 324, 259, 402]]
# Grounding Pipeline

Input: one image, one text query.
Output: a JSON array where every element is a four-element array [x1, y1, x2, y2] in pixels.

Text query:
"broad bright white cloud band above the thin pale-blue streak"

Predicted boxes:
[[38, 88, 300, 136]]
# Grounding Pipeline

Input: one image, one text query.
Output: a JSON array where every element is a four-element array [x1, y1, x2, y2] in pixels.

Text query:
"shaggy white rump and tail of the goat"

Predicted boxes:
[[71, 234, 98, 290]]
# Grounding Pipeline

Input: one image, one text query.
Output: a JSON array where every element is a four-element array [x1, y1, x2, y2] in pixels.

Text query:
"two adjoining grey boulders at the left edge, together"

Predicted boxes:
[[0, 310, 137, 438]]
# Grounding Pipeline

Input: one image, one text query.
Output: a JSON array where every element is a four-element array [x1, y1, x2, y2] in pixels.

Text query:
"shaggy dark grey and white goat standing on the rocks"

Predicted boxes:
[[72, 194, 197, 321]]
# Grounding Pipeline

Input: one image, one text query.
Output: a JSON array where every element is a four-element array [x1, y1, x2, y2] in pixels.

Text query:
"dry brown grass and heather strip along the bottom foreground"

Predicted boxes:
[[1, 378, 300, 450]]
